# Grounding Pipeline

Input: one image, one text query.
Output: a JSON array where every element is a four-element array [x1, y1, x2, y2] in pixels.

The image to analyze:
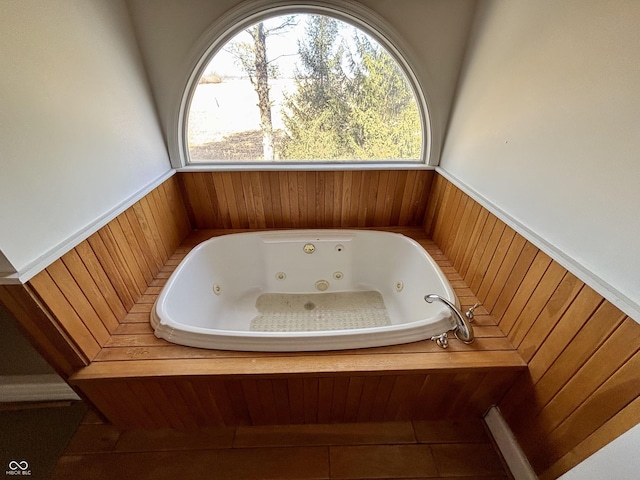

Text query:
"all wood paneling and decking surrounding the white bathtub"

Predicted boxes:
[[0, 170, 640, 479]]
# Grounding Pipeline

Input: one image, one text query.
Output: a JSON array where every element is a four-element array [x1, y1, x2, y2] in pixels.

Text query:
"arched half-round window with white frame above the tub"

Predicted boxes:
[[179, 2, 430, 167]]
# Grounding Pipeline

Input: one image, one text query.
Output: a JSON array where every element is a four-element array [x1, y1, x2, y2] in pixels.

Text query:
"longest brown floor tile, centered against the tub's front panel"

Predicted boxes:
[[233, 422, 416, 448]]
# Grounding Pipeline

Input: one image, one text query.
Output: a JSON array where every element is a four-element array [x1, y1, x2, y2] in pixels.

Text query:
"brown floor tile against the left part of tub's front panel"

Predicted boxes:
[[114, 427, 235, 452]]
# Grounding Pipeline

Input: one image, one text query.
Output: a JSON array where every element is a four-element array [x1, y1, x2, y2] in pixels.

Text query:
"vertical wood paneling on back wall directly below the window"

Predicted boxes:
[[178, 170, 434, 229]]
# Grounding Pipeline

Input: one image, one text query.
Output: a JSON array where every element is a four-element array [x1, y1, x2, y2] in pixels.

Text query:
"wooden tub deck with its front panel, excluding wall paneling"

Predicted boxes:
[[70, 227, 526, 428]]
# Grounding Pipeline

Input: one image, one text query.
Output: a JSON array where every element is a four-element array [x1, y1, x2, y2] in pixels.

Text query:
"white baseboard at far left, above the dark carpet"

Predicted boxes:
[[0, 374, 80, 403]]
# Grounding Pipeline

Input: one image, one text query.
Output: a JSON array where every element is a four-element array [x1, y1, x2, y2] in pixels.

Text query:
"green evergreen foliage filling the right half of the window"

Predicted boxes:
[[284, 16, 422, 160]]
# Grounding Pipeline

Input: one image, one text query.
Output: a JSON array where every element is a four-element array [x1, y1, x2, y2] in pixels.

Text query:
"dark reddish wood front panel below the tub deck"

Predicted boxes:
[[79, 372, 515, 429]]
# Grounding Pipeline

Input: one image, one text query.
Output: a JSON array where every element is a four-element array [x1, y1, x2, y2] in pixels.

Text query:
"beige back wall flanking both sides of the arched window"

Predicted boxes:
[[128, 0, 475, 167]]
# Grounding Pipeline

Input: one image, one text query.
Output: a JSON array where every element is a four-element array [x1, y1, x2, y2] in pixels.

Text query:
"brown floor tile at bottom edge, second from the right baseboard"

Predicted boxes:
[[329, 445, 437, 479]]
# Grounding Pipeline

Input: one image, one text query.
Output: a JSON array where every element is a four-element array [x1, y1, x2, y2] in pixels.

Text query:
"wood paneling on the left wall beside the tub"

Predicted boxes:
[[0, 177, 190, 368]]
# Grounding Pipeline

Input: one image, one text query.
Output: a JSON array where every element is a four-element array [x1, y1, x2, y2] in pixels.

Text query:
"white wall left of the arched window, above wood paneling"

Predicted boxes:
[[0, 0, 170, 282]]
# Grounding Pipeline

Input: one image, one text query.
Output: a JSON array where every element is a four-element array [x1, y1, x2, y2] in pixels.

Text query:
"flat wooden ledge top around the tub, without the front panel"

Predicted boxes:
[[69, 231, 526, 385]]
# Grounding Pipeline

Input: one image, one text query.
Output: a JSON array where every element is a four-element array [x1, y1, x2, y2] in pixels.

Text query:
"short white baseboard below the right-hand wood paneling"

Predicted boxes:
[[484, 406, 538, 480]]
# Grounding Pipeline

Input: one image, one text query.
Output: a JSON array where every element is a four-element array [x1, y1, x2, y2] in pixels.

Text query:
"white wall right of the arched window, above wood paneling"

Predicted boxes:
[[440, 0, 640, 321]]
